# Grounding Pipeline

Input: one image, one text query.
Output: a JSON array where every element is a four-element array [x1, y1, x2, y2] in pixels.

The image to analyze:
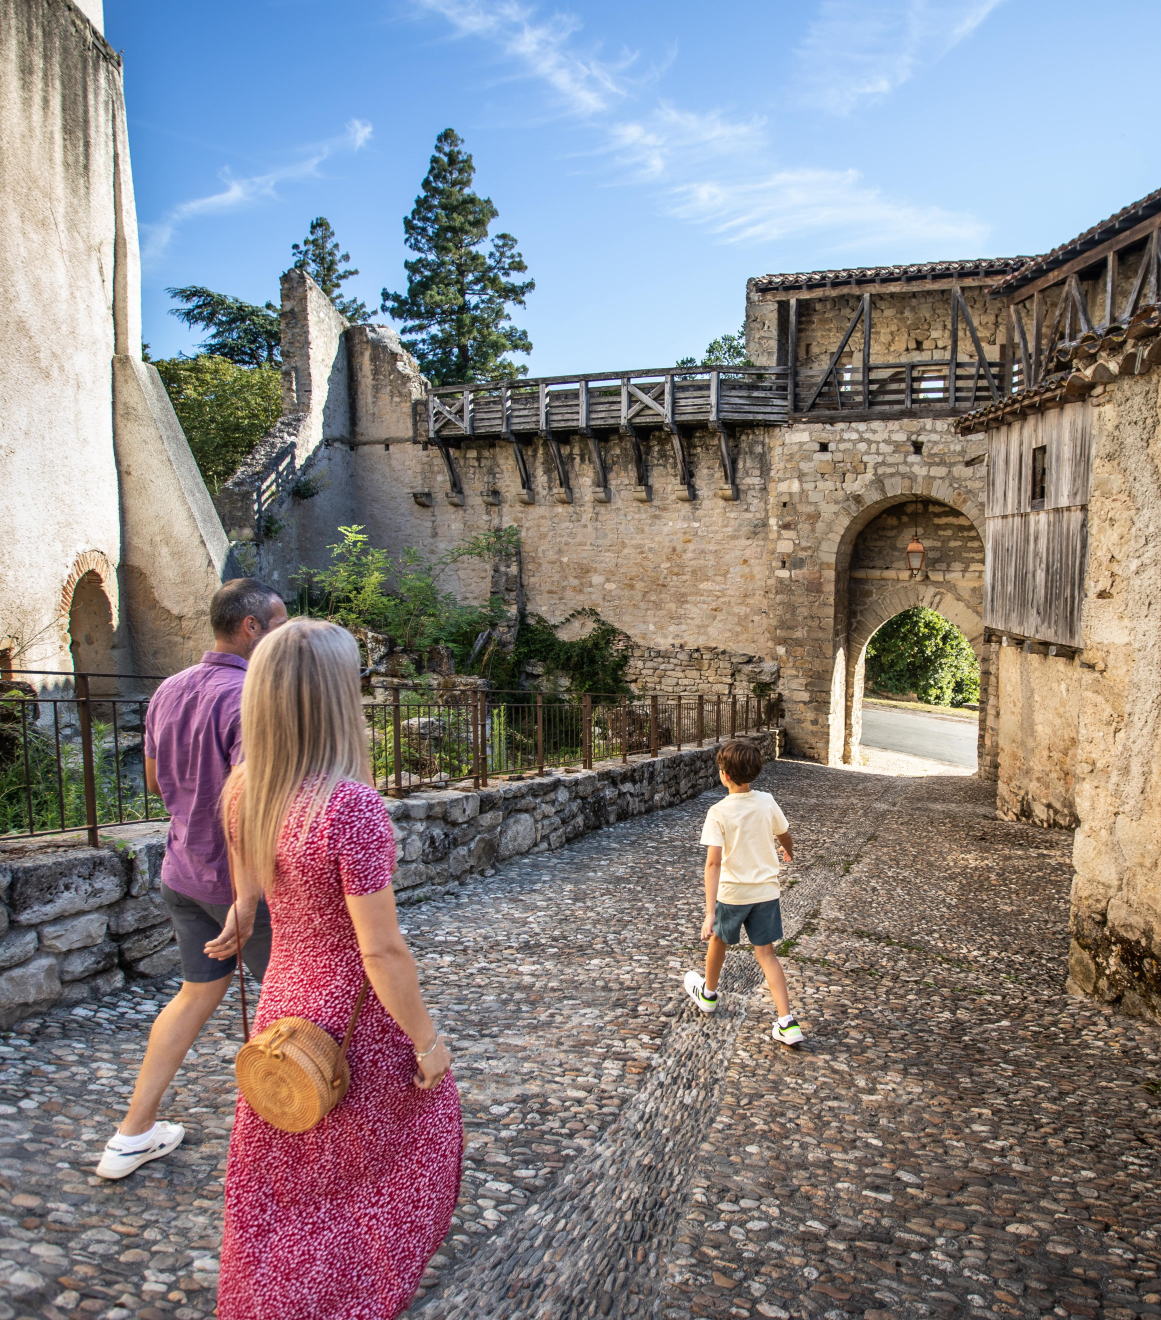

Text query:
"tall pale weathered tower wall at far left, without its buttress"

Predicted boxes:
[[0, 0, 127, 672]]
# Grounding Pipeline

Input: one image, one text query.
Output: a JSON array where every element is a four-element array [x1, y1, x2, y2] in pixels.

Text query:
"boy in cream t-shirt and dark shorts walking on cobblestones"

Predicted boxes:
[[685, 739, 802, 1045]]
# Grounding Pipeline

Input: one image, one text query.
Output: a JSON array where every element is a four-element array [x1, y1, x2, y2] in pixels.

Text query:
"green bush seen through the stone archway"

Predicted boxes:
[[867, 606, 979, 706]]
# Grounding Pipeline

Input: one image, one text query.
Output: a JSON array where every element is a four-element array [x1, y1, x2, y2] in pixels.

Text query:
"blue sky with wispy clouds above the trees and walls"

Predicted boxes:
[[106, 0, 1161, 374]]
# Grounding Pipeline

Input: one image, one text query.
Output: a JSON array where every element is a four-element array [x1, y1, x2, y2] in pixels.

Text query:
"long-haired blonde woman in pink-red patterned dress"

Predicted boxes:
[[206, 619, 463, 1320]]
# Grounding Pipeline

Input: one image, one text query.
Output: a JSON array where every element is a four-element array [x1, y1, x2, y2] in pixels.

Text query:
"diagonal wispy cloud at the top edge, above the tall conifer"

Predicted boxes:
[[416, 0, 637, 115]]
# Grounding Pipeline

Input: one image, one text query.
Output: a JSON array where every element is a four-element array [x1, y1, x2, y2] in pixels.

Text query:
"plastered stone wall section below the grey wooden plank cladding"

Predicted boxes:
[[996, 647, 1081, 829]]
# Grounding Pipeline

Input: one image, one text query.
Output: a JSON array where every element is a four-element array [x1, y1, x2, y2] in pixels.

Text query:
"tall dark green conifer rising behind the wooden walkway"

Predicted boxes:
[[381, 128, 536, 384]]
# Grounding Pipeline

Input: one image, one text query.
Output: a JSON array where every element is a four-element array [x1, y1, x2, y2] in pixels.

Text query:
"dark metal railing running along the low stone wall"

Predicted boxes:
[[0, 671, 780, 847]]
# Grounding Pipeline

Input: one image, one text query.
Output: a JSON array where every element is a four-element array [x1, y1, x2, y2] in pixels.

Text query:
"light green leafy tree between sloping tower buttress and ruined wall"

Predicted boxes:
[[154, 354, 282, 491]]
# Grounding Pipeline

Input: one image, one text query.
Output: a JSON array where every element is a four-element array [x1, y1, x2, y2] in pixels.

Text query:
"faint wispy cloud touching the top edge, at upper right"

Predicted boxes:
[[796, 0, 1003, 115]]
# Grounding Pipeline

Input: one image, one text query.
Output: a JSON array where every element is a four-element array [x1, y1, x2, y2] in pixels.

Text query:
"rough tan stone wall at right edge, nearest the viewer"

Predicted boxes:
[[1066, 371, 1161, 1016]]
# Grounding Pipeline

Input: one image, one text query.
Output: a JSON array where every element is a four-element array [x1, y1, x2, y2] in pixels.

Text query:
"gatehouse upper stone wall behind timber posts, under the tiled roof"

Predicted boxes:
[[745, 281, 1005, 368]]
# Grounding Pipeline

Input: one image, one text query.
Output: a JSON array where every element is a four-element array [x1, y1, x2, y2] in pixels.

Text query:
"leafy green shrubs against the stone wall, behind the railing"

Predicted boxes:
[[296, 525, 520, 665]]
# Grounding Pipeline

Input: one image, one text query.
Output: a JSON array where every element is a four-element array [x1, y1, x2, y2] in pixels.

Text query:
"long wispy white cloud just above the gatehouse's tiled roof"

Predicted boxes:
[[670, 169, 987, 256]]
